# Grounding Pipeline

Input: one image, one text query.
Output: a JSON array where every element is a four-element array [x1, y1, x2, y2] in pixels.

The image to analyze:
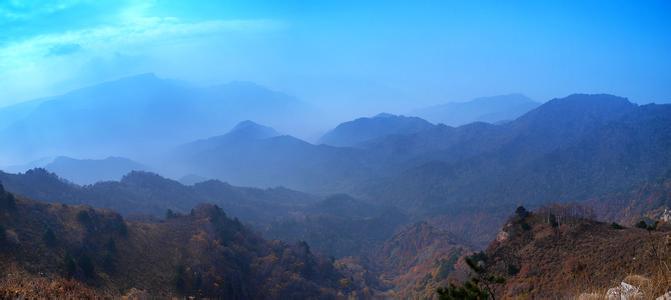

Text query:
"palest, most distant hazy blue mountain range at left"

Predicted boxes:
[[0, 74, 310, 165]]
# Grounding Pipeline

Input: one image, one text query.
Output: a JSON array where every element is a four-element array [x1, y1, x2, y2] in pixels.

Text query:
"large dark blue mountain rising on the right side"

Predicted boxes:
[[362, 94, 671, 220]]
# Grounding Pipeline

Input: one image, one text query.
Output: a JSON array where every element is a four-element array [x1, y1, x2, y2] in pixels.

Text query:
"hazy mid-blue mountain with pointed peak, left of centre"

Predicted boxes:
[[164, 122, 378, 192]]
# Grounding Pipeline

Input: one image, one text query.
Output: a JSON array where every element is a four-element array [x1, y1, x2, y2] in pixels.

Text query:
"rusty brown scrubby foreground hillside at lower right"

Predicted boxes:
[[483, 207, 671, 299]]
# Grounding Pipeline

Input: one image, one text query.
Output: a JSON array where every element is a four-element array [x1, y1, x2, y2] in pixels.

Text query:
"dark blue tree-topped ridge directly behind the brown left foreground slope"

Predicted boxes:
[[0, 169, 317, 223]]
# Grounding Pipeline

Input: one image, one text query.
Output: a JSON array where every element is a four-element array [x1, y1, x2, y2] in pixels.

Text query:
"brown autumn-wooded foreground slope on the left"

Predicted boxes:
[[0, 184, 366, 299]]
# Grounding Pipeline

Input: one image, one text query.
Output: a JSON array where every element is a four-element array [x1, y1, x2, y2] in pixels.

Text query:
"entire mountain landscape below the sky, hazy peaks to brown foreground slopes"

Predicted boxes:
[[0, 75, 671, 299]]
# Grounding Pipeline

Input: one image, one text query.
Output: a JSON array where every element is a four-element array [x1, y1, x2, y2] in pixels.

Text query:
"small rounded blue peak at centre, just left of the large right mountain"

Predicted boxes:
[[319, 113, 434, 146]]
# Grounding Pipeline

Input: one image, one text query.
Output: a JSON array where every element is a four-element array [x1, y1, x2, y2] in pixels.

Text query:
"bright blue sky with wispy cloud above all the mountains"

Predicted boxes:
[[0, 0, 671, 112]]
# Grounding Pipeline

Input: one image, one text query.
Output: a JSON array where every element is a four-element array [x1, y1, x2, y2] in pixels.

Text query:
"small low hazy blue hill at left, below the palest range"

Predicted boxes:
[[44, 156, 148, 185]]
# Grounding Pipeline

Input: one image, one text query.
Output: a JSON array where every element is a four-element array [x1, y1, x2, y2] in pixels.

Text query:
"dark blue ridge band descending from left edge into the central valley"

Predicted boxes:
[[0, 169, 409, 258]]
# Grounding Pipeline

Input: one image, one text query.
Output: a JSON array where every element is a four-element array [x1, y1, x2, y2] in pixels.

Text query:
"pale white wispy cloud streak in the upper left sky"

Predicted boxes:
[[0, 14, 285, 106]]
